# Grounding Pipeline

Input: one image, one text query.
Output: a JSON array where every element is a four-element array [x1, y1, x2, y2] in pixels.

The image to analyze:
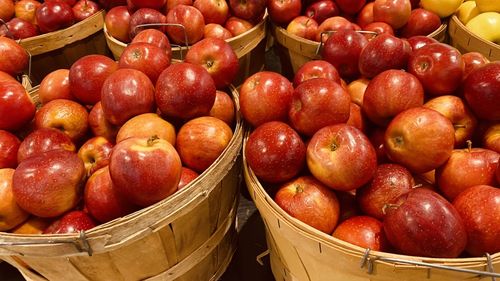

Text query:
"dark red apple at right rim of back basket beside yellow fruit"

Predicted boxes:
[[399, 8, 441, 38]]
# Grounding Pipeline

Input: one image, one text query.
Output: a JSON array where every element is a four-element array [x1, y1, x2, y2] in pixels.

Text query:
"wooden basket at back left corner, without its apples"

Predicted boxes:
[[19, 10, 111, 85]]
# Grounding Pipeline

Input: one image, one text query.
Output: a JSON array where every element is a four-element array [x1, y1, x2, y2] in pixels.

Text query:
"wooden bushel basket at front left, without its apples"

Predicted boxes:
[[0, 85, 243, 281]]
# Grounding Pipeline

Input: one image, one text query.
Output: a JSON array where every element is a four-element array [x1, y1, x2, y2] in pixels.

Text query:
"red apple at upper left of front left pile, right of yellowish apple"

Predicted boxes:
[[69, 55, 118, 105]]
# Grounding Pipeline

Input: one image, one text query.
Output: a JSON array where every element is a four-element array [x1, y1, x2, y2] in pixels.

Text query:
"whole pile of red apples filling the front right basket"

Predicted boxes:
[[240, 29, 500, 258]]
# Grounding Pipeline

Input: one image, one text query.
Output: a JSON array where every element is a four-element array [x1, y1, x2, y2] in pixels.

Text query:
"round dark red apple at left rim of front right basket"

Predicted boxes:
[[244, 121, 306, 183]]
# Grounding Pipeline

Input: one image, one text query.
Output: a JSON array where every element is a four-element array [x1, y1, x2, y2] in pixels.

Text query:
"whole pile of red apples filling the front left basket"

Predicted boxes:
[[0, 29, 238, 234]]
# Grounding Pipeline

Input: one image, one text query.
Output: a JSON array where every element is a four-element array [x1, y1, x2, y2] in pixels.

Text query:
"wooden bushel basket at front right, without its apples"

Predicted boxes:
[[243, 132, 500, 281]]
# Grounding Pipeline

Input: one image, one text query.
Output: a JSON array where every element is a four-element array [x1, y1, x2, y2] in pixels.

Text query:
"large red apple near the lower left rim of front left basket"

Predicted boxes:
[[12, 150, 85, 218]]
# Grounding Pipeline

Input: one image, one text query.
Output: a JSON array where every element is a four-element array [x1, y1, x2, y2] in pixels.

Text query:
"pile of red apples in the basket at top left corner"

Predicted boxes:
[[0, 0, 100, 40]]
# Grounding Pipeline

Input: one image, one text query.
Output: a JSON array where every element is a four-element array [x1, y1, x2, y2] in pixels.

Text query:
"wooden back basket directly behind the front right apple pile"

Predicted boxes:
[[271, 23, 447, 79]]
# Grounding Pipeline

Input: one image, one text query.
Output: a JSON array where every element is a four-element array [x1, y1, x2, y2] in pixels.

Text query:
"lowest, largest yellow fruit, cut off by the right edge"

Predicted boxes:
[[465, 12, 500, 42]]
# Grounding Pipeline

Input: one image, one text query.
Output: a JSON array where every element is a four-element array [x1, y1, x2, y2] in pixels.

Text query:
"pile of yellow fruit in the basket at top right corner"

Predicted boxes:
[[456, 0, 500, 44]]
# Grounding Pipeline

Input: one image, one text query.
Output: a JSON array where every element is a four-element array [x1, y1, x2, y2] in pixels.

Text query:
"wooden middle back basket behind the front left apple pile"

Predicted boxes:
[[104, 14, 268, 85]]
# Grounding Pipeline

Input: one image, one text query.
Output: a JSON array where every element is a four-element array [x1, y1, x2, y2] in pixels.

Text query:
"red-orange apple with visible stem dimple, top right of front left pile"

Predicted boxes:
[[185, 38, 239, 89]]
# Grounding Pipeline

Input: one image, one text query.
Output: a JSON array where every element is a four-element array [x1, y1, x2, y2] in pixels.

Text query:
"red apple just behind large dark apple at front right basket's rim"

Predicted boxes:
[[356, 163, 415, 220]]
